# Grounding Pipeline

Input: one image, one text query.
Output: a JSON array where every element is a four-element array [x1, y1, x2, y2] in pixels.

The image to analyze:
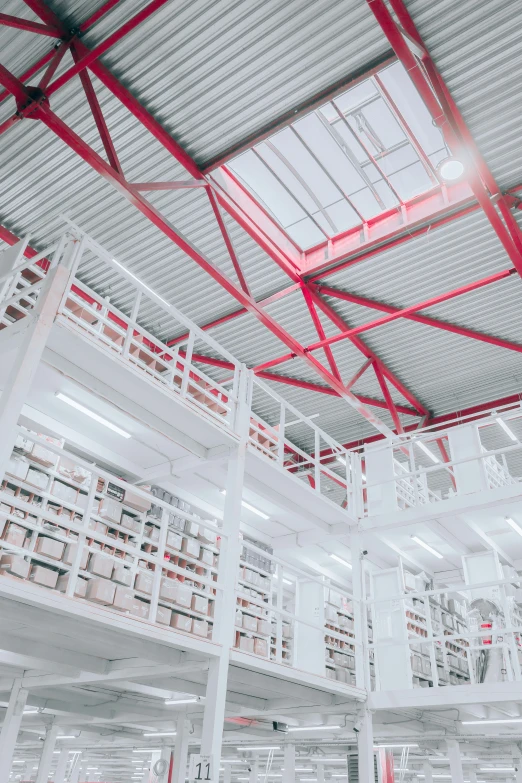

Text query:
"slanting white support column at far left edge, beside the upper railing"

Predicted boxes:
[[0, 264, 74, 476]]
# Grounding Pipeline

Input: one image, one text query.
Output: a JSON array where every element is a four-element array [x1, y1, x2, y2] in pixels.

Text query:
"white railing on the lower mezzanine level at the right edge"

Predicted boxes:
[[366, 578, 522, 691]]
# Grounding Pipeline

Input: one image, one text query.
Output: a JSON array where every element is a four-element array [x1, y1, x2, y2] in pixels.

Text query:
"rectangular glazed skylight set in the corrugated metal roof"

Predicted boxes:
[[227, 62, 449, 250]]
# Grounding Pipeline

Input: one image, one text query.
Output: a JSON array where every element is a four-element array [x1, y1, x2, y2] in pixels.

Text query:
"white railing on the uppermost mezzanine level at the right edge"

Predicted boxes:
[[361, 403, 522, 516]]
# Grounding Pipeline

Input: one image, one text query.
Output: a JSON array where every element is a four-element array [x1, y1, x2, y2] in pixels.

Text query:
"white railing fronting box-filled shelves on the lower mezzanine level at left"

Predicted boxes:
[[0, 428, 223, 639]]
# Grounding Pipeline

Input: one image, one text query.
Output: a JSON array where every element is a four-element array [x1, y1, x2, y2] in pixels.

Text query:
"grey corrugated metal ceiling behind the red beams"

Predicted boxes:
[[0, 0, 522, 448]]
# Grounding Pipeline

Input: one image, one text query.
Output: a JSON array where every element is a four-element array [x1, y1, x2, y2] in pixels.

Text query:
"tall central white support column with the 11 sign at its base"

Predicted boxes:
[[201, 367, 252, 783]]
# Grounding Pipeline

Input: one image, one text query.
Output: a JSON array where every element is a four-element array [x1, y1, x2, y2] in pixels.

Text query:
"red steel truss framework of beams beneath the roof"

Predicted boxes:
[[0, 0, 522, 435]]
